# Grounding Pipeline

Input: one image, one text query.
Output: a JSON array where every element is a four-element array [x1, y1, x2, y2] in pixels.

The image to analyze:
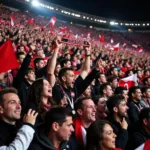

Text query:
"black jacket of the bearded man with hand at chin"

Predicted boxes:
[[105, 116, 128, 150]]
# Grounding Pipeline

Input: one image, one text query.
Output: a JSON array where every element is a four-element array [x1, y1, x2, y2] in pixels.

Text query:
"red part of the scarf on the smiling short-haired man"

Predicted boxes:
[[74, 118, 83, 145]]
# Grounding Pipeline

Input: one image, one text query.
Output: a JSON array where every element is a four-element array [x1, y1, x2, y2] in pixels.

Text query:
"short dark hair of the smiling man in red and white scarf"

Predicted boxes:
[[74, 96, 91, 111]]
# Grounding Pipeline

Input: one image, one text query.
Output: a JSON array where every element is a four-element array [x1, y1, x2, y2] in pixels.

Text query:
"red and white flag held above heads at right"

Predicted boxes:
[[119, 74, 137, 89]]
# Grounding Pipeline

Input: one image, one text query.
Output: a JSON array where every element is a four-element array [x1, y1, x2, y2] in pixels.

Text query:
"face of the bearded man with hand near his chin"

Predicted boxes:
[[118, 100, 128, 117]]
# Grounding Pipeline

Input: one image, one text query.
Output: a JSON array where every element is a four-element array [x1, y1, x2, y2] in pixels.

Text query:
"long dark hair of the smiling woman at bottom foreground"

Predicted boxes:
[[86, 120, 110, 150]]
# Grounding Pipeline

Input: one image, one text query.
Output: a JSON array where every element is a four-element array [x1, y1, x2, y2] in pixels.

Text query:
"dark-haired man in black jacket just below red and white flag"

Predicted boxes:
[[128, 86, 145, 123]]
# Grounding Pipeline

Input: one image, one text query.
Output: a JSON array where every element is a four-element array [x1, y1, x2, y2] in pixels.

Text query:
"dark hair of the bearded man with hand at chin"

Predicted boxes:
[[106, 94, 124, 114]]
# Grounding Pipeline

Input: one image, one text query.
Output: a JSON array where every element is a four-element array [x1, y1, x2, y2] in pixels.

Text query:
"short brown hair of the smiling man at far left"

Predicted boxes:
[[0, 87, 18, 105]]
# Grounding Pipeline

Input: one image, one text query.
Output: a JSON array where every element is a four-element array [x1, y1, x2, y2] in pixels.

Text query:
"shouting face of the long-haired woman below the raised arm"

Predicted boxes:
[[42, 80, 52, 98]]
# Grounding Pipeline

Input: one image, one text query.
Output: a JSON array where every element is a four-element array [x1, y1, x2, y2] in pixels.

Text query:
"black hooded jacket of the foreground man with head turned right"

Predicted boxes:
[[28, 125, 79, 150]]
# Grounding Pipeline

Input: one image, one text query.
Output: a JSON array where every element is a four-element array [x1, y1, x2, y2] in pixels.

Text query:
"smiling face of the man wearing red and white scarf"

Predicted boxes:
[[81, 99, 96, 123]]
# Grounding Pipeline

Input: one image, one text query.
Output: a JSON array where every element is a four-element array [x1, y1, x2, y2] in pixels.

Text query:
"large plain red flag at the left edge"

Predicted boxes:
[[0, 40, 19, 73]]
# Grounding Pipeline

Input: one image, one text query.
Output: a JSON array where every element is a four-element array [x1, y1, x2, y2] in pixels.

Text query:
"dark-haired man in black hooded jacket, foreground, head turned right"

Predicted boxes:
[[29, 107, 78, 150]]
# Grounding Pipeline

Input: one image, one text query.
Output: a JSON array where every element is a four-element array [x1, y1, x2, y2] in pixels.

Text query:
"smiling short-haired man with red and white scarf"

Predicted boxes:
[[74, 97, 96, 149]]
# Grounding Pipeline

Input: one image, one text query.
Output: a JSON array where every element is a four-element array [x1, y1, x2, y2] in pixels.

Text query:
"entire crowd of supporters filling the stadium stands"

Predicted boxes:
[[0, 6, 150, 150]]
